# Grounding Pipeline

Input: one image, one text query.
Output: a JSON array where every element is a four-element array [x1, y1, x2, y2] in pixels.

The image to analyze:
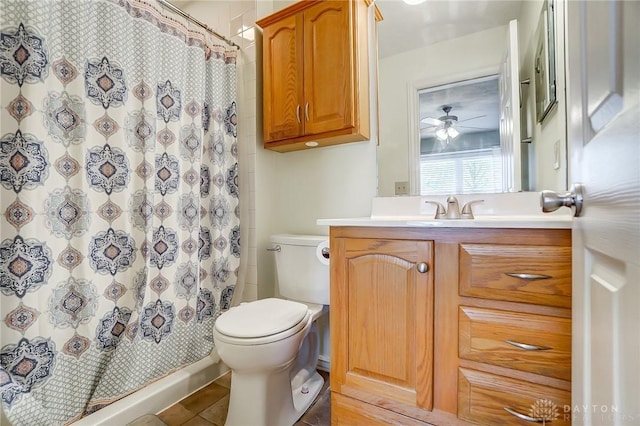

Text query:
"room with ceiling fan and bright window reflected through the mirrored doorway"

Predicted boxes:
[[418, 75, 504, 195]]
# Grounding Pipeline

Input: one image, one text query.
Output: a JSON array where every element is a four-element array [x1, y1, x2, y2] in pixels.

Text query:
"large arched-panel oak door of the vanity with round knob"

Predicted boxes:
[[331, 238, 433, 413]]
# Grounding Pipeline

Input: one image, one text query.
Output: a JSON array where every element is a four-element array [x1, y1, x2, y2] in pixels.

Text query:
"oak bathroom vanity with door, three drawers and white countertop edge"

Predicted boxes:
[[318, 199, 571, 425]]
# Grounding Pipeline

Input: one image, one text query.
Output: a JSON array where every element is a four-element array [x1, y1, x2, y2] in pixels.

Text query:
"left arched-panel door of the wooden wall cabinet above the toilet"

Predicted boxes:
[[263, 14, 304, 141]]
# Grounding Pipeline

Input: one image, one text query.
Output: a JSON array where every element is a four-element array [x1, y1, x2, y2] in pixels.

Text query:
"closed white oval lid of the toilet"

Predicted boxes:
[[215, 298, 309, 339]]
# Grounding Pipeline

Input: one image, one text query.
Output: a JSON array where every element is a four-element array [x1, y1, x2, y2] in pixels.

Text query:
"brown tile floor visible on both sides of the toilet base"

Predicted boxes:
[[127, 371, 331, 426]]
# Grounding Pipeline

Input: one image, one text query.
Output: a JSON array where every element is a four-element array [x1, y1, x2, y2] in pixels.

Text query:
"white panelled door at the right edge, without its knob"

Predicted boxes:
[[566, 0, 640, 425]]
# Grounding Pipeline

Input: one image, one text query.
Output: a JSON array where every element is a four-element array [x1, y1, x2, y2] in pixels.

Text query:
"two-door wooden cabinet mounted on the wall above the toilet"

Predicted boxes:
[[257, 0, 370, 152]]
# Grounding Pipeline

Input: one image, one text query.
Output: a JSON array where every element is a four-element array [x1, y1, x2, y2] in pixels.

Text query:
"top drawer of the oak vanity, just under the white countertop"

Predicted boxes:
[[459, 243, 571, 308]]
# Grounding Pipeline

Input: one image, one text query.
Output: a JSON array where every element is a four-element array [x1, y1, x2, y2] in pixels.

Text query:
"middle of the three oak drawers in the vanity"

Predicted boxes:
[[458, 306, 571, 380]]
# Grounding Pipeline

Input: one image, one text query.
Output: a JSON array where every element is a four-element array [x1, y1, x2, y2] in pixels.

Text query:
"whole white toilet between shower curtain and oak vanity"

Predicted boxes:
[[213, 234, 329, 426]]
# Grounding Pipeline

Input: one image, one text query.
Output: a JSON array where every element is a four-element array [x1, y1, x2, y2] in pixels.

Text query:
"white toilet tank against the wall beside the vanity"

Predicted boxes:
[[271, 234, 329, 305]]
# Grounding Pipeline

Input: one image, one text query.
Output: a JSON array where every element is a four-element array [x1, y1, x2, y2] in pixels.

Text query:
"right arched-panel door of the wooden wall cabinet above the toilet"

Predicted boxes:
[[304, 1, 356, 135]]
